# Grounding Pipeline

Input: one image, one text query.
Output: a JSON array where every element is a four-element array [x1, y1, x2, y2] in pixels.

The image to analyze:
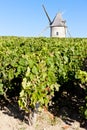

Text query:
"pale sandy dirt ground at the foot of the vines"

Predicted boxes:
[[0, 100, 86, 130]]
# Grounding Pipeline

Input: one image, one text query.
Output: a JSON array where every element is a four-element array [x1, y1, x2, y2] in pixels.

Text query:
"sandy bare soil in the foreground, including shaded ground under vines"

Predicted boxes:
[[0, 95, 87, 130]]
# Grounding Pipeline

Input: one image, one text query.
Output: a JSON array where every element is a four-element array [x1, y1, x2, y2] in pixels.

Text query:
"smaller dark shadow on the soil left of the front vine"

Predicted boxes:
[[0, 97, 28, 124]]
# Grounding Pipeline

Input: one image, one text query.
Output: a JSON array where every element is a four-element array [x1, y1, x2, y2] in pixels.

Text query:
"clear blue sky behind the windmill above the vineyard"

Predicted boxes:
[[0, 0, 87, 37]]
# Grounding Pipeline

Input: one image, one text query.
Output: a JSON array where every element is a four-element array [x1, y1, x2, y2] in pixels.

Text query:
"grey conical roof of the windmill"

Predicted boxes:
[[51, 13, 66, 27]]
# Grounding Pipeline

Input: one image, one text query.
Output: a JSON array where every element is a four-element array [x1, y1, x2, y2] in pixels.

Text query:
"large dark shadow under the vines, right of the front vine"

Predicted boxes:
[[49, 85, 87, 129]]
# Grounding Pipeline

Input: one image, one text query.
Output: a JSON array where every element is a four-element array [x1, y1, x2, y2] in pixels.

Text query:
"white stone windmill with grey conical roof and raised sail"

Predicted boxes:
[[42, 5, 67, 37]]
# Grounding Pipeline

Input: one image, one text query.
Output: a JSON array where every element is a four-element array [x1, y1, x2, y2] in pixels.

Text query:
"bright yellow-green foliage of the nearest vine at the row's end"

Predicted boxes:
[[19, 51, 59, 111]]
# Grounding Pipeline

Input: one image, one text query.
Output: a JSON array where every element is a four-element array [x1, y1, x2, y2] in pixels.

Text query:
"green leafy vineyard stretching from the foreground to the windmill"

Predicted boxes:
[[0, 36, 87, 125]]
